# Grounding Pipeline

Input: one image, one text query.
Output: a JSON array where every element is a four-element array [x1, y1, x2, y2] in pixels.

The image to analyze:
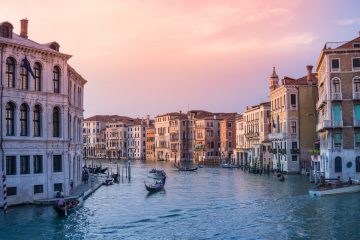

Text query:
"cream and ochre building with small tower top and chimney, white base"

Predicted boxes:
[[269, 66, 318, 173]]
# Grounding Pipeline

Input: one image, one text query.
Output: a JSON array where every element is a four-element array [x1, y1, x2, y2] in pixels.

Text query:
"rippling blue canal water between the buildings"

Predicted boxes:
[[0, 161, 360, 239]]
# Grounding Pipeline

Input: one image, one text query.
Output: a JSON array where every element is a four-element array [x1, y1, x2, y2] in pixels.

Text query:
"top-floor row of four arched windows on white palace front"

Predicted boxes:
[[5, 57, 61, 93]]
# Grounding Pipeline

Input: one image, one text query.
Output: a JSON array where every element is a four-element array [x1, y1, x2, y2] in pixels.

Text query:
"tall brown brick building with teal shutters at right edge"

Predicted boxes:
[[316, 33, 360, 180]]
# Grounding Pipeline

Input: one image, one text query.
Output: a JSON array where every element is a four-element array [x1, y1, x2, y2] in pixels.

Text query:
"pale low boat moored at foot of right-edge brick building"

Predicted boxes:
[[309, 182, 360, 197]]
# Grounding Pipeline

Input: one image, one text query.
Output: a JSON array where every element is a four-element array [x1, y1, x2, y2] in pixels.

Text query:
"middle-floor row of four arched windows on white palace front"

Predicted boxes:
[[5, 102, 61, 137]]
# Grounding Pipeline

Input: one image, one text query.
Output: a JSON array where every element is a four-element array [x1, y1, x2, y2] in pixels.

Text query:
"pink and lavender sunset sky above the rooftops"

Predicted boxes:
[[0, 0, 360, 117]]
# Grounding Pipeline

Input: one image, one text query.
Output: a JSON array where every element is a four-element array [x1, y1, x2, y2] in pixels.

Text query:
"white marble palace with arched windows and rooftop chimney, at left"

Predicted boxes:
[[0, 19, 86, 206]]
